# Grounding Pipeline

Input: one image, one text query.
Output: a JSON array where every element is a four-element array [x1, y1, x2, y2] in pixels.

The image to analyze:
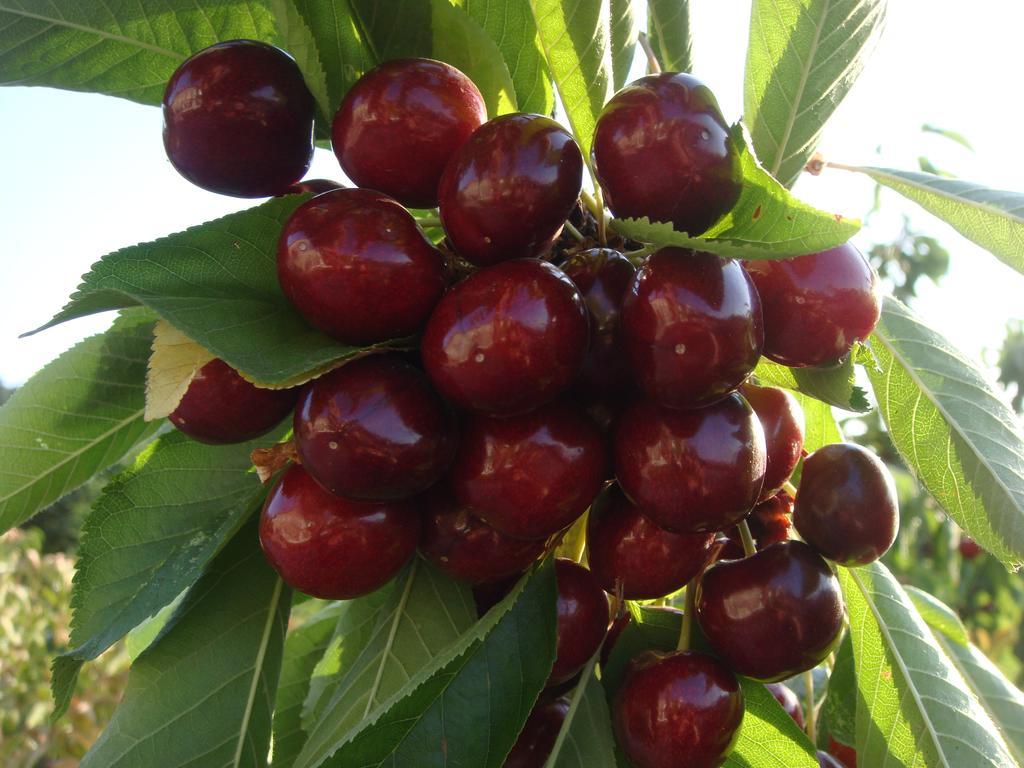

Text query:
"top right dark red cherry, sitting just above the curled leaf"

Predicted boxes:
[[593, 72, 741, 234]]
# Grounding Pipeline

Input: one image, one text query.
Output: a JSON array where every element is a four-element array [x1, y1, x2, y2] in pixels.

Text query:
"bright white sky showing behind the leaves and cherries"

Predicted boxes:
[[0, 0, 1024, 393]]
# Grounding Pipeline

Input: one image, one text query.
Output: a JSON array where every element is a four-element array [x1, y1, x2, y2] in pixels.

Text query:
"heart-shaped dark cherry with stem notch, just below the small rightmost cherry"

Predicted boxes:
[[696, 541, 845, 682]]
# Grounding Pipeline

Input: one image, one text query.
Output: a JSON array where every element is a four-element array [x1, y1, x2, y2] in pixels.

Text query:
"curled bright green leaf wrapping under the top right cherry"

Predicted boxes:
[[611, 124, 860, 259]]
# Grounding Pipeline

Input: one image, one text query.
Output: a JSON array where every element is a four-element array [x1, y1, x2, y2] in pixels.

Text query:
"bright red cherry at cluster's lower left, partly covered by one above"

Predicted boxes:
[[259, 465, 420, 600]]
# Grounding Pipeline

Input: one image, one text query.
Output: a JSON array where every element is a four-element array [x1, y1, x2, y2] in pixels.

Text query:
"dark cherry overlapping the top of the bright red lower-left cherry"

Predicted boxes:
[[295, 354, 458, 500]]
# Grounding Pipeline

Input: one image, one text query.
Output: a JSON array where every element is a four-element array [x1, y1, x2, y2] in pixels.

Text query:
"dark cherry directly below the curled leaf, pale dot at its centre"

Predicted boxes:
[[622, 248, 763, 408]]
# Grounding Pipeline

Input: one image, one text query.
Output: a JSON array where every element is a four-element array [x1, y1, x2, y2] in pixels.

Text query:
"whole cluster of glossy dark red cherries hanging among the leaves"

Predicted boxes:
[[164, 41, 897, 768]]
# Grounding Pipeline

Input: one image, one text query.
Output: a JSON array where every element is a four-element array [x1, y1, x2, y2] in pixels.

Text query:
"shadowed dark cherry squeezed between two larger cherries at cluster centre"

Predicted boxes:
[[562, 248, 637, 397]]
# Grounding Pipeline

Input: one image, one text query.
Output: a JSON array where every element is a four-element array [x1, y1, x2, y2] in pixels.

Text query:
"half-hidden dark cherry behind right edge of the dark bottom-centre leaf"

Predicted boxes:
[[548, 557, 608, 685]]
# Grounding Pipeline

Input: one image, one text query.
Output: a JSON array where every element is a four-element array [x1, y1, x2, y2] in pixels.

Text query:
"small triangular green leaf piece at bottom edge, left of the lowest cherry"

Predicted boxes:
[[545, 653, 615, 768]]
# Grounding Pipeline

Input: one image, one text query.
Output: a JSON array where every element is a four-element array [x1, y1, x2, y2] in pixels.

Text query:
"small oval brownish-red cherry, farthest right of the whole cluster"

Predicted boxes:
[[793, 442, 899, 566]]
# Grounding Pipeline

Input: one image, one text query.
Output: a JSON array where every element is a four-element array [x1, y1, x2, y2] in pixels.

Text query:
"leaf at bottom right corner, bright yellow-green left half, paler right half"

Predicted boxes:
[[839, 562, 1016, 768]]
